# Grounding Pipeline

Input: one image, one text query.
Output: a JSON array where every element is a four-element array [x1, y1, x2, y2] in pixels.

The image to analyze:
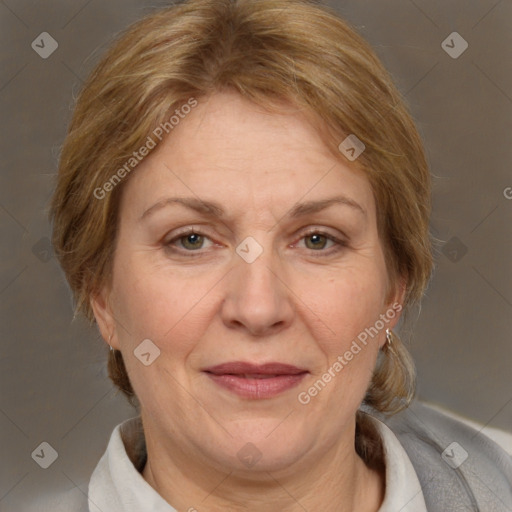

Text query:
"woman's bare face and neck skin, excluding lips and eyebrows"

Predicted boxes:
[[91, 92, 403, 512]]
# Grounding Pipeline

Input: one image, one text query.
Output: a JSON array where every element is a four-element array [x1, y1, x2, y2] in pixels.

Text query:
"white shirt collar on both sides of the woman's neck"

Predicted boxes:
[[89, 416, 427, 512]]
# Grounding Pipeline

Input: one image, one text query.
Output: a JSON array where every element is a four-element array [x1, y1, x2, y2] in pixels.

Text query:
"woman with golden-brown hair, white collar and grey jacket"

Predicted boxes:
[[52, 0, 512, 512]]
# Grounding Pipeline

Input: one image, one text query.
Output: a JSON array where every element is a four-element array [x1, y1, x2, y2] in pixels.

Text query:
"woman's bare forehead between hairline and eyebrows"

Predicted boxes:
[[123, 92, 374, 220]]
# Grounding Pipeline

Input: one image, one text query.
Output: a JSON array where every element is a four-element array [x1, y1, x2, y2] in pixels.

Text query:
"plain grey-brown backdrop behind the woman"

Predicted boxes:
[[0, 0, 512, 512]]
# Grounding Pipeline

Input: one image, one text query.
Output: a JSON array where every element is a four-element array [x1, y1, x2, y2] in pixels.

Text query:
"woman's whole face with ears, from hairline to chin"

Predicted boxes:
[[92, 92, 399, 471]]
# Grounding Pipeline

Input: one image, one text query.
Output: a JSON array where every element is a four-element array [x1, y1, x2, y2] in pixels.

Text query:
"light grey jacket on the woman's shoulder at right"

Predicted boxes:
[[375, 402, 512, 512]]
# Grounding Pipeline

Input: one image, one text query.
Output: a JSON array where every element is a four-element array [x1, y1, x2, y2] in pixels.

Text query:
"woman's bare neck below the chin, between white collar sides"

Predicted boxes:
[[142, 420, 385, 512]]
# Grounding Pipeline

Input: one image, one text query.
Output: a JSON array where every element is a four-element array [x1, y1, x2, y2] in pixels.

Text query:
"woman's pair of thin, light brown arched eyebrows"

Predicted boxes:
[[139, 196, 366, 221]]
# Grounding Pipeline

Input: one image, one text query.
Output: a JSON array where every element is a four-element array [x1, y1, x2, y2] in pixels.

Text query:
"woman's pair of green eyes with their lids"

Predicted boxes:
[[164, 227, 348, 258]]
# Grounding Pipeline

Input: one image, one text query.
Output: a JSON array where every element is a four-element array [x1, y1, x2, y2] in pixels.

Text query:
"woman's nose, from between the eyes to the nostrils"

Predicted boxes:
[[221, 242, 294, 337]]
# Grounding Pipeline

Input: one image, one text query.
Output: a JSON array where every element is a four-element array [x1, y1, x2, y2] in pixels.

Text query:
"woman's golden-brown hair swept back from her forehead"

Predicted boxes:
[[50, 0, 432, 456]]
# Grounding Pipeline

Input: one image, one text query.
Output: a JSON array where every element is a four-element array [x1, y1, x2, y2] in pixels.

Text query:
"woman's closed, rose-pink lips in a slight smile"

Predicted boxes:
[[203, 361, 309, 400]]
